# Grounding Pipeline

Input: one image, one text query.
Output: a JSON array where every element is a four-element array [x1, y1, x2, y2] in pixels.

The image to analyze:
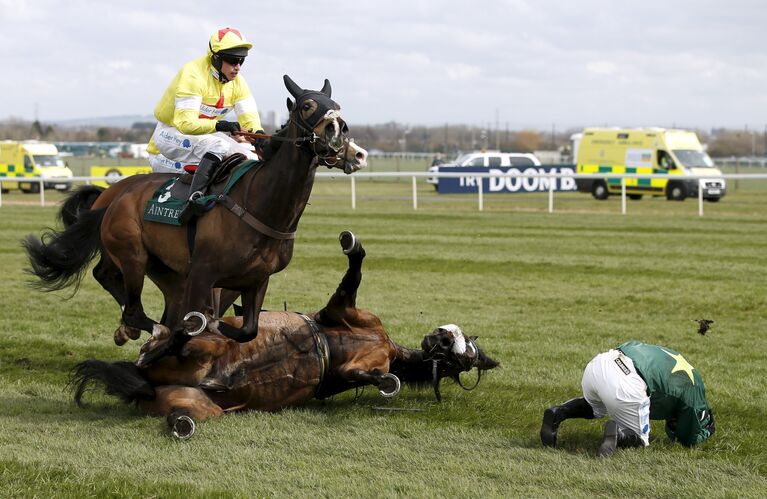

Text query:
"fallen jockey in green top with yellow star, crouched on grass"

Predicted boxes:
[[540, 341, 716, 457]]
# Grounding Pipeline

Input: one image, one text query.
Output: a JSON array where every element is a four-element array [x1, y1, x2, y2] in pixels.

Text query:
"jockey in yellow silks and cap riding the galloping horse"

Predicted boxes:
[[147, 28, 263, 222]]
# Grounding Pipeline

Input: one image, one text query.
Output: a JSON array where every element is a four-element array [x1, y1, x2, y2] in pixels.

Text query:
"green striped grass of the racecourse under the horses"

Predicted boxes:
[[0, 186, 767, 498]]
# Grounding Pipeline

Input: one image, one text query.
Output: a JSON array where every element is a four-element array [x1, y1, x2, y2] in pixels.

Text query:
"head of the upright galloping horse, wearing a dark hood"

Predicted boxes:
[[283, 75, 368, 175]]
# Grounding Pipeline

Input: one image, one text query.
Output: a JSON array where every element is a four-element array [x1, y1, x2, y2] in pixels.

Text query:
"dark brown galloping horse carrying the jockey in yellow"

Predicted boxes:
[[24, 75, 367, 362]]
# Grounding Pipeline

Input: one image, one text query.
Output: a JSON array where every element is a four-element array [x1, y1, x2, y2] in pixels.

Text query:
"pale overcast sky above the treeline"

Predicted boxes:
[[0, 0, 767, 131]]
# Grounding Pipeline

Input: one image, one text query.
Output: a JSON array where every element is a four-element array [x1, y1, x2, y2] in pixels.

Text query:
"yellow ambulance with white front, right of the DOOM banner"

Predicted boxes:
[[571, 128, 727, 202]]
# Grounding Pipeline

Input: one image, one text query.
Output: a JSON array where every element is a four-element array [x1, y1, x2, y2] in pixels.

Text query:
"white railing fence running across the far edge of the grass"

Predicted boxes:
[[0, 172, 767, 216]]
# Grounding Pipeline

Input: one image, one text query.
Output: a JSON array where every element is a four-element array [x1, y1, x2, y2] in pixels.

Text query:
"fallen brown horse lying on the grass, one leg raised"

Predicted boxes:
[[72, 232, 498, 438]]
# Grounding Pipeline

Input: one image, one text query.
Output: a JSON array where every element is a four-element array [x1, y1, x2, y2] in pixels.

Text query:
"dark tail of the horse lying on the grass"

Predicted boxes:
[[69, 359, 155, 406]]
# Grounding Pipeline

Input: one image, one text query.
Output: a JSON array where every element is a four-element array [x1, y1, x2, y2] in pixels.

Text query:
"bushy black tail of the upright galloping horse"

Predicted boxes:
[[22, 208, 106, 291]]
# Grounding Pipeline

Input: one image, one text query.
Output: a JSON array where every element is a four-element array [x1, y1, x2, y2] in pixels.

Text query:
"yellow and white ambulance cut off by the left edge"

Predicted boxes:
[[0, 140, 73, 192]]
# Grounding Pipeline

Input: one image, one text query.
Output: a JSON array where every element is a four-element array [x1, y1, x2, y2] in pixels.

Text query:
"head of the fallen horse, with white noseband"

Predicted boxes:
[[421, 324, 499, 400]]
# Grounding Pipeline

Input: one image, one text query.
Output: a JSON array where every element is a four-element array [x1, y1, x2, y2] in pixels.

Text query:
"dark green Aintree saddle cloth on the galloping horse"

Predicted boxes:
[[144, 159, 263, 226]]
